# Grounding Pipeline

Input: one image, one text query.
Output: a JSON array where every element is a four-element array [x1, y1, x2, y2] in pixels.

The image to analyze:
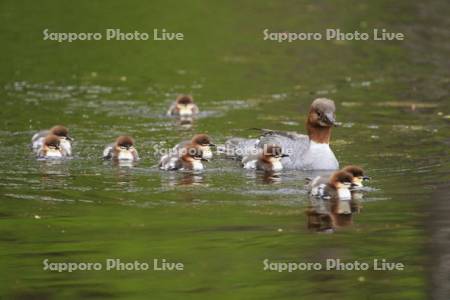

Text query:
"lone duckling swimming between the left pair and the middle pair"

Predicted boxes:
[[103, 135, 139, 161]]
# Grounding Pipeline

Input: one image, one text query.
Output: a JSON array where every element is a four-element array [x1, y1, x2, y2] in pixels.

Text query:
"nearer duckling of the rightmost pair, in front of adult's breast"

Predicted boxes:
[[307, 171, 353, 200]]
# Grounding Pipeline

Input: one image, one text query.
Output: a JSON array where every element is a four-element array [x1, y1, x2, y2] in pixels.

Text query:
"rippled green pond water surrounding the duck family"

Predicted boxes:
[[0, 0, 450, 299]]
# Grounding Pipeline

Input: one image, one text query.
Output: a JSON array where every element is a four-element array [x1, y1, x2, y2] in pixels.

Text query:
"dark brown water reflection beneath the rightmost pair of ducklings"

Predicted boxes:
[[306, 197, 361, 233]]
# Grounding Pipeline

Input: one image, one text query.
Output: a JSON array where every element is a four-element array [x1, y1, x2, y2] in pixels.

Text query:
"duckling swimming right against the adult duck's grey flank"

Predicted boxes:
[[242, 145, 288, 172]]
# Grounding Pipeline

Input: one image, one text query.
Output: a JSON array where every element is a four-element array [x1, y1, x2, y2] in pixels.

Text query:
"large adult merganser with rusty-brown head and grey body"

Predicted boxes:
[[221, 98, 339, 170]]
